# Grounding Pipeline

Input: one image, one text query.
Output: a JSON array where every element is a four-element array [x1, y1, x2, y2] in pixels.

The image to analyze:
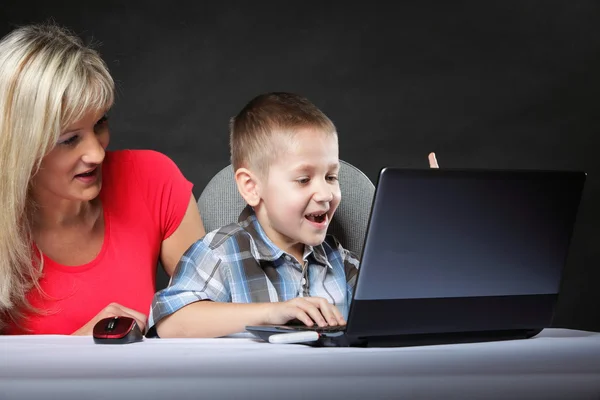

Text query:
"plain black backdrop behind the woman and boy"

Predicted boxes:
[[0, 0, 600, 331]]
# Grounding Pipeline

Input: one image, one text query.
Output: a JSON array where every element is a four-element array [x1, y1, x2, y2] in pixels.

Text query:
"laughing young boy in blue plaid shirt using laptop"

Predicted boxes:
[[148, 93, 359, 337]]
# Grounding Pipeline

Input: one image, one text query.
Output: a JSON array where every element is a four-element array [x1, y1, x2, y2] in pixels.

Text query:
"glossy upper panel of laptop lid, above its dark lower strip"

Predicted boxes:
[[354, 168, 585, 300]]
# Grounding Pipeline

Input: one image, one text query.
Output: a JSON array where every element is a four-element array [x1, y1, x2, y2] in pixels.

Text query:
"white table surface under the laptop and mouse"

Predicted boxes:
[[0, 329, 600, 400]]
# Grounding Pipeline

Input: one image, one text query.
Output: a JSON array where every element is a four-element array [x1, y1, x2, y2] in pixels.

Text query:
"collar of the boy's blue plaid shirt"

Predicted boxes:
[[238, 205, 331, 267]]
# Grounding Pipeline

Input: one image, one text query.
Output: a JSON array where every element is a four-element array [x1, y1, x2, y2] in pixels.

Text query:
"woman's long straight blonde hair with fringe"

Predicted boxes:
[[0, 23, 114, 332]]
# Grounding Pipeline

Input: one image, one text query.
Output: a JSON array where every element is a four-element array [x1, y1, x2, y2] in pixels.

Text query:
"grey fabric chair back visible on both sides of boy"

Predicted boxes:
[[198, 160, 375, 256]]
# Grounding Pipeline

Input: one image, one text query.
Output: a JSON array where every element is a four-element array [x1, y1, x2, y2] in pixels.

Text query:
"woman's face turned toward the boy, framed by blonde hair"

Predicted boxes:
[[32, 111, 110, 203]]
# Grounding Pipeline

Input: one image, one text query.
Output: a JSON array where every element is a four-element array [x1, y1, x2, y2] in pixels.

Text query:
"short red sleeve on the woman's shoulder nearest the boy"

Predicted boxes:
[[130, 150, 193, 240]]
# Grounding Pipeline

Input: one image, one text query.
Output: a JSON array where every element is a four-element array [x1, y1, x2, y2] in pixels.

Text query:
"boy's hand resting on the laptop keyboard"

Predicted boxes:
[[266, 297, 346, 326]]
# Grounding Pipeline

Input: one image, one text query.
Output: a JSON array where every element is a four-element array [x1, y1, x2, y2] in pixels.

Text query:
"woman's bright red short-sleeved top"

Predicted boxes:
[[6, 150, 192, 334]]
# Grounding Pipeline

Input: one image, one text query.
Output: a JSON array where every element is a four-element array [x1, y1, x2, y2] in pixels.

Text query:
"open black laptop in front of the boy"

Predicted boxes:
[[246, 167, 586, 347]]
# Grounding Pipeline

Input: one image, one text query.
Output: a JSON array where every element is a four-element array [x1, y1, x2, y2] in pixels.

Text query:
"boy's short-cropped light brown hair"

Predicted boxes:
[[229, 92, 337, 176]]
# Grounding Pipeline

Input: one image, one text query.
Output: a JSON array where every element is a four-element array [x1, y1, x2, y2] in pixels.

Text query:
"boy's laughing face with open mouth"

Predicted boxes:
[[255, 129, 341, 258]]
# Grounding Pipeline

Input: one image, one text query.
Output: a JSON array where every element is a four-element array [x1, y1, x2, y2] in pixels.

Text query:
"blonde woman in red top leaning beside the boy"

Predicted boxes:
[[0, 21, 205, 335]]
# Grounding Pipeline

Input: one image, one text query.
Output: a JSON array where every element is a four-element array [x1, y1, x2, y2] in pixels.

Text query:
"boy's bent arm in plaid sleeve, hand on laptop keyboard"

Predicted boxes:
[[148, 238, 345, 338]]
